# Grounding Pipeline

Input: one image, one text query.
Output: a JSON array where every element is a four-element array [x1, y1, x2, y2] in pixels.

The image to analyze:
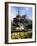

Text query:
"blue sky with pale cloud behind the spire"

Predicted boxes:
[[11, 6, 32, 20]]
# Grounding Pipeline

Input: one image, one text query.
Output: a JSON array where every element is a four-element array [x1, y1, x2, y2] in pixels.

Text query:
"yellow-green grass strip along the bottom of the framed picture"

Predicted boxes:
[[11, 31, 32, 39]]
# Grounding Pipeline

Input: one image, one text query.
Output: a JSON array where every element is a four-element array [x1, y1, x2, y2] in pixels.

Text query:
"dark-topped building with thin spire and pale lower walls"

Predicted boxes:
[[14, 11, 26, 31]]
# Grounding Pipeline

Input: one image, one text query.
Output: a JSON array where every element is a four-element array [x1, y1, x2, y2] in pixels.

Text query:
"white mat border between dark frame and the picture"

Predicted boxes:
[[8, 4, 35, 43]]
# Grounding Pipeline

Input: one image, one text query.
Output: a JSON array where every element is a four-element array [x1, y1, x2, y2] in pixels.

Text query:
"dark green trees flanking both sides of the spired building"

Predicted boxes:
[[11, 16, 32, 31]]
